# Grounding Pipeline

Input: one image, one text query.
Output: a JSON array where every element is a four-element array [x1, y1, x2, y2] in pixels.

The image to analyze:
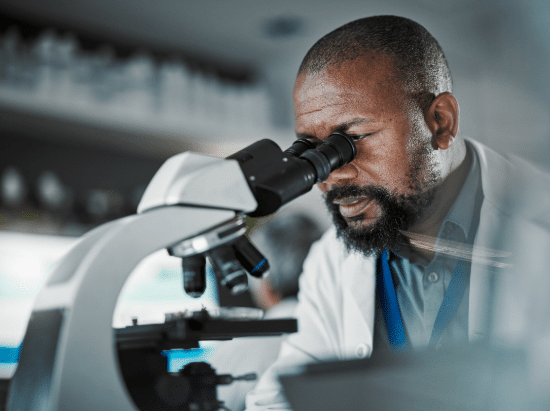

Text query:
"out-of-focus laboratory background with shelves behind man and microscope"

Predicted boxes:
[[0, 0, 550, 371]]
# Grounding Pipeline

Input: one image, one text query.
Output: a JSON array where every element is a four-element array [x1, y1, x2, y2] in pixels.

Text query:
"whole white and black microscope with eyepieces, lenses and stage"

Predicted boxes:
[[7, 133, 356, 411]]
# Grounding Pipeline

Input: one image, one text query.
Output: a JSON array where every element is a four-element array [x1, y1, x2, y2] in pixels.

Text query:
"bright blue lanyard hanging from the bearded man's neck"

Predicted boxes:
[[376, 249, 468, 351]]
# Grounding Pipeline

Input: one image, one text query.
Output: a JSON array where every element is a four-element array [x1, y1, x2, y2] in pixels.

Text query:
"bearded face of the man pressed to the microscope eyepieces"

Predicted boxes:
[[294, 54, 439, 254]]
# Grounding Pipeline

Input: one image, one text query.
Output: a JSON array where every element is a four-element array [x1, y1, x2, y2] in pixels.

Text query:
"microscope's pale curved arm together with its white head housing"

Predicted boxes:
[[7, 153, 257, 411]]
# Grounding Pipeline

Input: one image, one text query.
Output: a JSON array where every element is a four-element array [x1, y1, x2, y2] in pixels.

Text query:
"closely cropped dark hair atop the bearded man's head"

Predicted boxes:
[[299, 16, 452, 96]]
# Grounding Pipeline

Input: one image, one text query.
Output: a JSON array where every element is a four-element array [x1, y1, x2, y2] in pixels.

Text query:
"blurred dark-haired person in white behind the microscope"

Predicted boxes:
[[209, 211, 322, 411]]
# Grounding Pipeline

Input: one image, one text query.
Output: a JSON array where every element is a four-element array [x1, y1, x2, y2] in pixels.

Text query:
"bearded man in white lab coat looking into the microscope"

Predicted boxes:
[[247, 16, 528, 410]]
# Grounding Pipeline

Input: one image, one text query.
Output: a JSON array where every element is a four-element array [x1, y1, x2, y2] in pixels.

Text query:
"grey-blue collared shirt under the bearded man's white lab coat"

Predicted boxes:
[[375, 143, 483, 348]]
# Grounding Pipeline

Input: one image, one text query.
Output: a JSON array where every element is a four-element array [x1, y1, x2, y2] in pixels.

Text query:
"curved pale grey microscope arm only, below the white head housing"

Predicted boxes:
[[7, 206, 235, 411]]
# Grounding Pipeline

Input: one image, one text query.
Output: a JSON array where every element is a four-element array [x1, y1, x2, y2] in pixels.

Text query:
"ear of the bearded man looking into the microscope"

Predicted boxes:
[[426, 91, 459, 150]]
